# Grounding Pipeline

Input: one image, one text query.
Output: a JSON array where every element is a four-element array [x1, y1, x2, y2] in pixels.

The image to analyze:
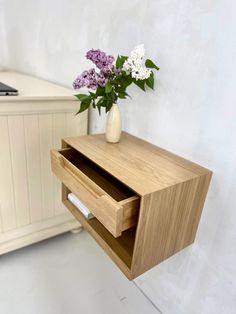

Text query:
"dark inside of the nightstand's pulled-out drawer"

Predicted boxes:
[[60, 147, 136, 202]]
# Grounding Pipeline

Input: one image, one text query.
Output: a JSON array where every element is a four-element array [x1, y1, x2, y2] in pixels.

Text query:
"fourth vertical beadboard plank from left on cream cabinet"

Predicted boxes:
[[39, 114, 54, 219]]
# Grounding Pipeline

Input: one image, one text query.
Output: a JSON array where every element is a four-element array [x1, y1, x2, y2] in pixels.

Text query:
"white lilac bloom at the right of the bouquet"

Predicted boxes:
[[123, 45, 152, 80]]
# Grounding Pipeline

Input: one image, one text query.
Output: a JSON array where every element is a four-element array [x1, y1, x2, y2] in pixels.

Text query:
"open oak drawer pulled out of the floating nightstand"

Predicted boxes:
[[51, 147, 140, 237]]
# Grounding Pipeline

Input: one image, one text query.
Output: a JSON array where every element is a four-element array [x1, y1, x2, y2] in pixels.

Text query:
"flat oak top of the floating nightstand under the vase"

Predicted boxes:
[[64, 132, 210, 195]]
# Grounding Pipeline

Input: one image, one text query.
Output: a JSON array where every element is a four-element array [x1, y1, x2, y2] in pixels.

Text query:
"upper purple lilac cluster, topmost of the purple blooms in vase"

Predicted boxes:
[[86, 49, 115, 76]]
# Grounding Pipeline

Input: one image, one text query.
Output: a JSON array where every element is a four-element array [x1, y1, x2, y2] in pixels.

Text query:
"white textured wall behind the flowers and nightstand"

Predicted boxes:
[[0, 0, 236, 314]]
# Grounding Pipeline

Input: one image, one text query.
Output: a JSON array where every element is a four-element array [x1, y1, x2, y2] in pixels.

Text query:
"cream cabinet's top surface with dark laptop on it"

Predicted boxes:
[[0, 71, 75, 102]]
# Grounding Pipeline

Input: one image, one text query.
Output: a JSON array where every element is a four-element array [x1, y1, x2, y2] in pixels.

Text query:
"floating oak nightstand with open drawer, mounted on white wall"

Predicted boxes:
[[51, 133, 212, 279]]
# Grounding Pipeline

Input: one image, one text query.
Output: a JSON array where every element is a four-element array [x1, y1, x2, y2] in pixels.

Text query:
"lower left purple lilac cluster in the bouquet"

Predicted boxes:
[[73, 69, 107, 90]]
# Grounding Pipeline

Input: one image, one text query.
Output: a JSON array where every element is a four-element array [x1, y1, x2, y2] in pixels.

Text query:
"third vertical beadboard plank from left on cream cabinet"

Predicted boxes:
[[24, 115, 42, 223]]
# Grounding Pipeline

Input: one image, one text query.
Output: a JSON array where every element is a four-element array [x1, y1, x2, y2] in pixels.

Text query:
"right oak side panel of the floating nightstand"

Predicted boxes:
[[131, 172, 211, 277]]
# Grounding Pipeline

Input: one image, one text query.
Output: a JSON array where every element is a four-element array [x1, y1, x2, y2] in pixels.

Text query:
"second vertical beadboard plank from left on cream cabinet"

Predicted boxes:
[[8, 116, 30, 227]]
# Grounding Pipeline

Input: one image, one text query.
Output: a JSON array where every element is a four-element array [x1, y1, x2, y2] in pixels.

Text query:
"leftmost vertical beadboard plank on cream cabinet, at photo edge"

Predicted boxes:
[[0, 116, 16, 231]]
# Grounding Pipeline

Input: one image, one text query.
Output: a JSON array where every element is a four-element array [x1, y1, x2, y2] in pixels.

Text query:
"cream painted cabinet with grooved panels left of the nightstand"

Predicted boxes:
[[0, 72, 87, 254]]
